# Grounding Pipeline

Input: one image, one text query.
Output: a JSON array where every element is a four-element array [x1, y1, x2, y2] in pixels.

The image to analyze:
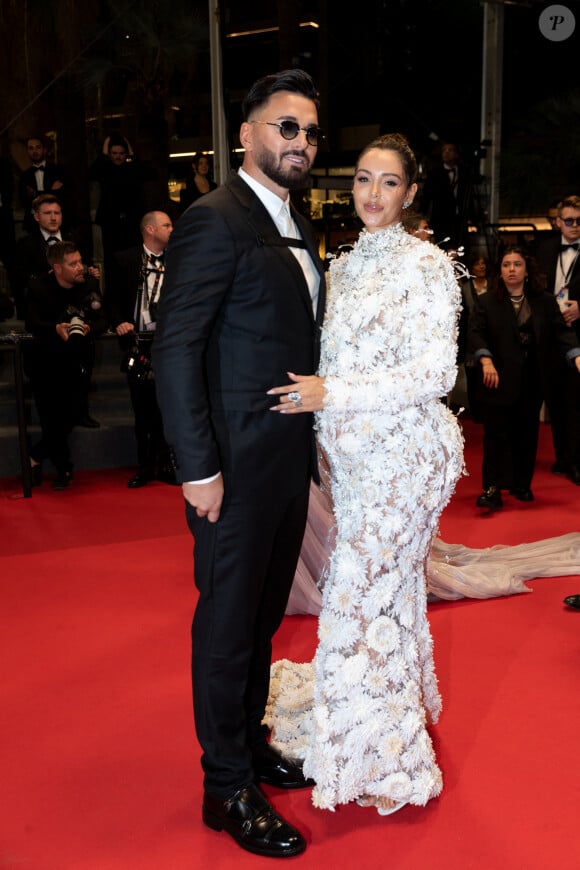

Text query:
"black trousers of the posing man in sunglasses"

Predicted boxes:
[[186, 485, 309, 799]]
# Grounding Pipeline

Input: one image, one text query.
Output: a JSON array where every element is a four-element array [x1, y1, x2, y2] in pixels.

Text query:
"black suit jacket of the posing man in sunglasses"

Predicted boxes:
[[153, 173, 325, 495]]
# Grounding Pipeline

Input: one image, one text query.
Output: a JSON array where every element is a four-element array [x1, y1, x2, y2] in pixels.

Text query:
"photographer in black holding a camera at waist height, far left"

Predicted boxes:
[[26, 242, 107, 490]]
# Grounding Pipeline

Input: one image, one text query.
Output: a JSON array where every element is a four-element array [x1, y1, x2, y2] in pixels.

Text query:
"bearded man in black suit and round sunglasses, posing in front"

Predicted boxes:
[[153, 69, 325, 857]]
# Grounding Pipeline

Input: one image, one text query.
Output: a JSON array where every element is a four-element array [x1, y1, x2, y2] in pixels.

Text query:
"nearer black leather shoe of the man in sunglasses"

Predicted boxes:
[[202, 785, 306, 858]]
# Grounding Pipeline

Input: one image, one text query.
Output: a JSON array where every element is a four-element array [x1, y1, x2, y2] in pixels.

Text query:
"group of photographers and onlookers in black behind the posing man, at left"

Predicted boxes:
[[0, 134, 216, 491]]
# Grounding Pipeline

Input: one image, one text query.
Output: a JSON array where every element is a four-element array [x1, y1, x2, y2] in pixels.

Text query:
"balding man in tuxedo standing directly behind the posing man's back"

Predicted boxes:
[[106, 211, 175, 489]]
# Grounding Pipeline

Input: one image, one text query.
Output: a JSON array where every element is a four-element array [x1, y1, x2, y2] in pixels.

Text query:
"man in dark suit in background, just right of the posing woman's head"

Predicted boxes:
[[420, 142, 473, 250]]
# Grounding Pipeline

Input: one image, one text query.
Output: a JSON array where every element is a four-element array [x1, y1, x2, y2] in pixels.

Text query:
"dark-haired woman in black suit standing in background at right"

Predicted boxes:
[[468, 245, 580, 510]]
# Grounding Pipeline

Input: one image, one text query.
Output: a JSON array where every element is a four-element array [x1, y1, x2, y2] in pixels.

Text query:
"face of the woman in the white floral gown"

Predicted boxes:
[[352, 148, 417, 233]]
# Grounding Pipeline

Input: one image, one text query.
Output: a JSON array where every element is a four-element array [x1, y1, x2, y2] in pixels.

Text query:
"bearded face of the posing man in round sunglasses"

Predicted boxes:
[[241, 91, 318, 195]]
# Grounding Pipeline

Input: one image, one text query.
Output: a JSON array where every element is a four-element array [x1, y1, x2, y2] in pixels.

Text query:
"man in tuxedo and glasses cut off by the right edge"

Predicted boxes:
[[537, 196, 580, 486]]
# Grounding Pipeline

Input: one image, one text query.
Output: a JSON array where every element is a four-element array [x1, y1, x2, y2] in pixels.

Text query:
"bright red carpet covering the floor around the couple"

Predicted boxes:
[[0, 420, 580, 870]]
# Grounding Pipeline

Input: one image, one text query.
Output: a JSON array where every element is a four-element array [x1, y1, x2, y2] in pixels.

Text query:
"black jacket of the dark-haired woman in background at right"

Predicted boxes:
[[468, 292, 579, 405]]
